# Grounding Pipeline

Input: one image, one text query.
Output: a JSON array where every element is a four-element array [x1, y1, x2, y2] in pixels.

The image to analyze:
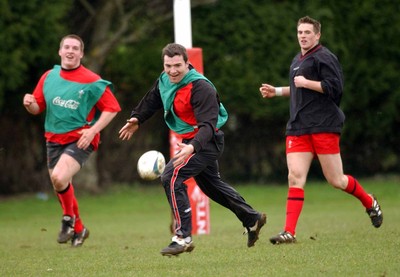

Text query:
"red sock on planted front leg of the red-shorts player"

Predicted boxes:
[[285, 188, 304, 235]]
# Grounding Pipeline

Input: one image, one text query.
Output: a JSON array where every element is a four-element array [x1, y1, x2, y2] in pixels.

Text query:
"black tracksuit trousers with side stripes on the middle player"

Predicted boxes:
[[161, 130, 259, 237]]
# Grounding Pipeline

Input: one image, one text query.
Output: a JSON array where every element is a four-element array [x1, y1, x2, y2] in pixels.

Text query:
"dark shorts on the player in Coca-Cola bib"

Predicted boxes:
[[46, 142, 93, 169]]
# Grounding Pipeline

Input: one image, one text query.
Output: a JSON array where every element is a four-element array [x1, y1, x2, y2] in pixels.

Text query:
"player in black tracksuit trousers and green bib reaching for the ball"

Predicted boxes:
[[119, 43, 266, 256]]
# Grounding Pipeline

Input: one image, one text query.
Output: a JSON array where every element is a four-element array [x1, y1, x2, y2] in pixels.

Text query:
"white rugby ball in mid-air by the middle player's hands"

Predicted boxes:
[[137, 150, 165, 181]]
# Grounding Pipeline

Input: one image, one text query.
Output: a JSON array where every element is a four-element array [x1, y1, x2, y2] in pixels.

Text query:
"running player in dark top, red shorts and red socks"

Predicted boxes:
[[260, 16, 383, 244]]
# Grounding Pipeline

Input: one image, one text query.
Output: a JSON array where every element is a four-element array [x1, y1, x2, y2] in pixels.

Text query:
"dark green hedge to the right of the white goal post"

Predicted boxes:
[[192, 0, 400, 181]]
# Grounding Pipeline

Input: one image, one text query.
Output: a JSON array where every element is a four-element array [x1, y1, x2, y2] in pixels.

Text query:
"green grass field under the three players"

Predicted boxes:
[[0, 178, 400, 276]]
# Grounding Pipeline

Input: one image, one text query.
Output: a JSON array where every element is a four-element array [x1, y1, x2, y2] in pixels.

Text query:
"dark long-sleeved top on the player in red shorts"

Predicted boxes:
[[286, 45, 345, 136]]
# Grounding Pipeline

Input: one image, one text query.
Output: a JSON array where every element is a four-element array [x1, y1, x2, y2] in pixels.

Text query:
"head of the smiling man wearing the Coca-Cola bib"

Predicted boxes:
[[58, 38, 83, 69]]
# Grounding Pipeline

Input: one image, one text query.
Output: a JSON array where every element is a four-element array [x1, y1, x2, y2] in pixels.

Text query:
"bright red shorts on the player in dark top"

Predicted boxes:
[[286, 133, 340, 154]]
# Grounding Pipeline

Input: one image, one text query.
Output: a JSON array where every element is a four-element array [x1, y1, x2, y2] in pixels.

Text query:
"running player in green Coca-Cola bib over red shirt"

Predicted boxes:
[[23, 35, 121, 247]]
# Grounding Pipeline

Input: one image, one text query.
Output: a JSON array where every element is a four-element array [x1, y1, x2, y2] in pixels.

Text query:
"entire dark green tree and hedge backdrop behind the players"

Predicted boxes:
[[0, 0, 400, 194]]
